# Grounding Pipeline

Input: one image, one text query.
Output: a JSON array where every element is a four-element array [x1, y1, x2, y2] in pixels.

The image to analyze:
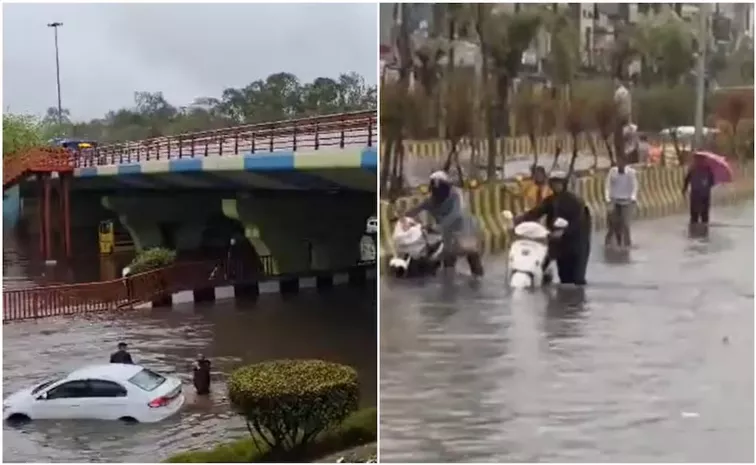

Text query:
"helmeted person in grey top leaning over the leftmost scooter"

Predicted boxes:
[[402, 171, 483, 277]]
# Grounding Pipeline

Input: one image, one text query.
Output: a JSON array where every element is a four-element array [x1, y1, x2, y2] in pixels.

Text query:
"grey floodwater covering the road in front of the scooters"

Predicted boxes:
[[380, 205, 754, 462]]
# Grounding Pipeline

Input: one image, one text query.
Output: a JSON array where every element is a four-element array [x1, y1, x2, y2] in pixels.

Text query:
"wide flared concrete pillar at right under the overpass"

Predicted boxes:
[[223, 191, 375, 273]]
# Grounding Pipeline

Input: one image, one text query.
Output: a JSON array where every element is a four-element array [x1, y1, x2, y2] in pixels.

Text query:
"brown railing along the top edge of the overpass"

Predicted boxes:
[[76, 110, 378, 167]]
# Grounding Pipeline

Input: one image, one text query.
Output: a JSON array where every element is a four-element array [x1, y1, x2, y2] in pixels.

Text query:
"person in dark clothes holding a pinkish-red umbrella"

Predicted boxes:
[[682, 151, 732, 226]]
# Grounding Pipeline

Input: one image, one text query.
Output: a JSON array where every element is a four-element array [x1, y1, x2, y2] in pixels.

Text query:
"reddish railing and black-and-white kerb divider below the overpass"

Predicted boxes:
[[3, 261, 376, 323]]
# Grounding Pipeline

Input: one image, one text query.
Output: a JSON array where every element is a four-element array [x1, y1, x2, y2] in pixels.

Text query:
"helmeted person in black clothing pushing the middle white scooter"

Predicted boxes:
[[515, 171, 591, 285]]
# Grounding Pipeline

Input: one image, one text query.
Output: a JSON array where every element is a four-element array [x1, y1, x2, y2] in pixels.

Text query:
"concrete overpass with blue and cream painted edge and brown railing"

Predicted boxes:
[[8, 111, 378, 273]]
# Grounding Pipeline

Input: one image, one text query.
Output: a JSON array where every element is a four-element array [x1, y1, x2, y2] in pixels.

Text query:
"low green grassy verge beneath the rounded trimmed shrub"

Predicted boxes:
[[166, 408, 378, 463]]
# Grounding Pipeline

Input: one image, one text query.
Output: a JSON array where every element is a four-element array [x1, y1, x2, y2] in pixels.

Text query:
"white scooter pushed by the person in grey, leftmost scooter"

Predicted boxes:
[[389, 218, 444, 277]]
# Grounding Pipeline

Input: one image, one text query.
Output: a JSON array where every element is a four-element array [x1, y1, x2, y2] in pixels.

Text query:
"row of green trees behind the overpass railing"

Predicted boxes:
[[44, 72, 377, 143]]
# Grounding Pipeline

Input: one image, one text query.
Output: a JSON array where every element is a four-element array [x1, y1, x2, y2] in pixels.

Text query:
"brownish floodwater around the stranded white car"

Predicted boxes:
[[3, 237, 377, 462]]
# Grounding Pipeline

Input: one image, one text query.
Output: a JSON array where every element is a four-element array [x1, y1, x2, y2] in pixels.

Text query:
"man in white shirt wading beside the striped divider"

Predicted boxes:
[[604, 156, 638, 247]]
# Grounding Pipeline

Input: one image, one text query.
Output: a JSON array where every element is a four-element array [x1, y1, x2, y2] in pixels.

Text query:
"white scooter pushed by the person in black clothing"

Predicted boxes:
[[501, 210, 569, 289]]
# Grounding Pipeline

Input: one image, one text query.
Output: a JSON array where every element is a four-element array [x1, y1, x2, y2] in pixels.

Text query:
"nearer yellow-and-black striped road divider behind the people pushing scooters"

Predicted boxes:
[[380, 163, 754, 261]]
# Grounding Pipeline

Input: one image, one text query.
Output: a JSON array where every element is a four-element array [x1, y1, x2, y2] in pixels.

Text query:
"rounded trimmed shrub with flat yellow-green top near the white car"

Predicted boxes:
[[228, 360, 359, 458]]
